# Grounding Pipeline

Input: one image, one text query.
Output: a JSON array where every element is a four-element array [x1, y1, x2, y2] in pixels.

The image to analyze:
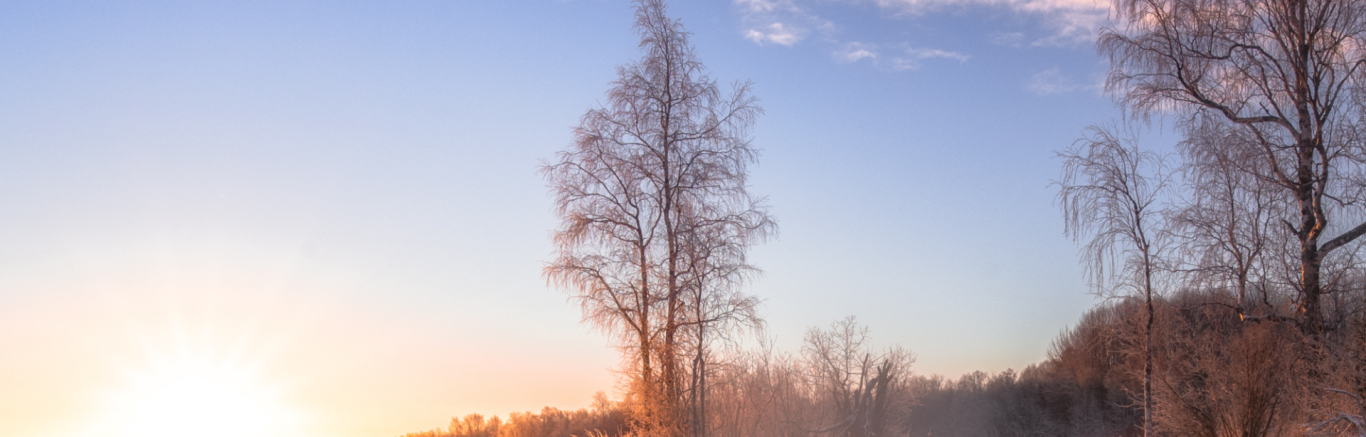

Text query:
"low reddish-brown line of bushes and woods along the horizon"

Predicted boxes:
[[404, 287, 1366, 437]]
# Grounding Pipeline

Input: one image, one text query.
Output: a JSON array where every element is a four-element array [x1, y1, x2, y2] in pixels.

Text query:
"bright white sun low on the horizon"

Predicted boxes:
[[105, 346, 298, 437]]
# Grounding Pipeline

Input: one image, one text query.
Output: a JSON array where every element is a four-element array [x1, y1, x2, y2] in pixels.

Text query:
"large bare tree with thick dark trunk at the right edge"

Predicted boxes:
[[1098, 0, 1366, 333]]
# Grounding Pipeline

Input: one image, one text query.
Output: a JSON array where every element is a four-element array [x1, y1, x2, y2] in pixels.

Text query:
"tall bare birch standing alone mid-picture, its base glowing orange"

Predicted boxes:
[[542, 0, 776, 436]]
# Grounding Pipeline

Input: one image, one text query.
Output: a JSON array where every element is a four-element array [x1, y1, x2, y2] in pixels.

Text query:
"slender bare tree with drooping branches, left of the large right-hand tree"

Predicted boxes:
[[1056, 127, 1168, 436]]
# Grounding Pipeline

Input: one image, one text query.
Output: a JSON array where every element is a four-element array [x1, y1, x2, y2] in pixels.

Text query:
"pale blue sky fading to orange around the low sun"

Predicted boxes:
[[0, 0, 1120, 437]]
